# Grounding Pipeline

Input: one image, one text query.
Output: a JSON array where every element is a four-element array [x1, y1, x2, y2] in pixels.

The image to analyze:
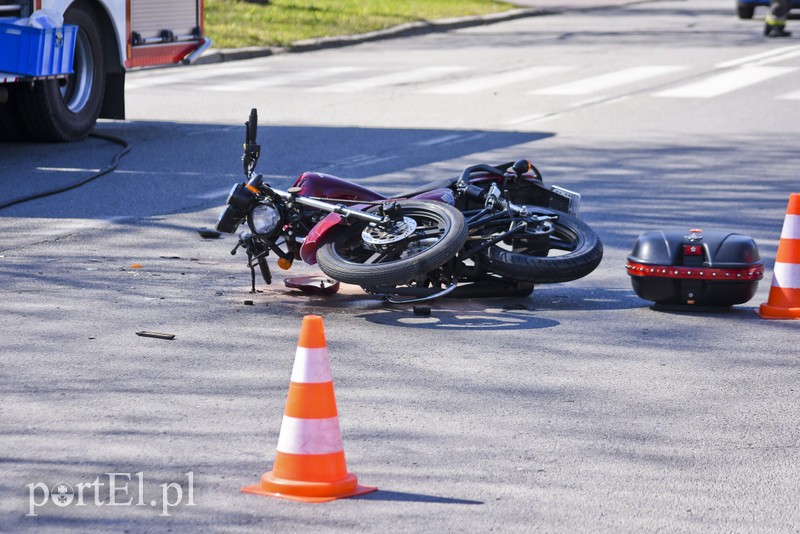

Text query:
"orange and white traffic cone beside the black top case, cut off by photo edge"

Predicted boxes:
[[758, 193, 800, 319]]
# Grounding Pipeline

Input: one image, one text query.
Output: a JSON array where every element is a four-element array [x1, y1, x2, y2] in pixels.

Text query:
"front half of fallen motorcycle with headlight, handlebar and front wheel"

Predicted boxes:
[[217, 109, 467, 298]]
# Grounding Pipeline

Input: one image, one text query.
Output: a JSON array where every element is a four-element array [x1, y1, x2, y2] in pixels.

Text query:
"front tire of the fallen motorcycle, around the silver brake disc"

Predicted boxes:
[[317, 200, 467, 287]]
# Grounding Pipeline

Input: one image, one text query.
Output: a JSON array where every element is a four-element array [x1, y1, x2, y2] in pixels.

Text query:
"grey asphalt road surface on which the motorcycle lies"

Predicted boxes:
[[0, 0, 800, 532]]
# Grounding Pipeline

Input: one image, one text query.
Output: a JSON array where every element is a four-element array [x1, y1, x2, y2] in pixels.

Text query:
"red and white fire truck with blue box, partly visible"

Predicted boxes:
[[0, 0, 211, 142]]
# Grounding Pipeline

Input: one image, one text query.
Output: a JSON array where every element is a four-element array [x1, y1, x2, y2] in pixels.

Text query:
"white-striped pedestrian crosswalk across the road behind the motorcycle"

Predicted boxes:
[[126, 61, 800, 101]]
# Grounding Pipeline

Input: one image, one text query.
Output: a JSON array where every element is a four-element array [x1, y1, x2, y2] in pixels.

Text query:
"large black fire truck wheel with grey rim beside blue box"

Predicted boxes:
[[16, 2, 105, 142]]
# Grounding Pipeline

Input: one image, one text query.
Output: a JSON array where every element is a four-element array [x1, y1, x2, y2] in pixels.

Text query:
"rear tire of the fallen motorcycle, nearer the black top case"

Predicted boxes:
[[479, 213, 603, 284]]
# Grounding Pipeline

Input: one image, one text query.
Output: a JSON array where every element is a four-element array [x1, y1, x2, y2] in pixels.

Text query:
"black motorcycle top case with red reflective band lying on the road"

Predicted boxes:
[[627, 230, 764, 306]]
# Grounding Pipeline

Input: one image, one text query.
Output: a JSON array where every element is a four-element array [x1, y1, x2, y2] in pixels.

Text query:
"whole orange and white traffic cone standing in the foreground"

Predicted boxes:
[[242, 315, 378, 502]]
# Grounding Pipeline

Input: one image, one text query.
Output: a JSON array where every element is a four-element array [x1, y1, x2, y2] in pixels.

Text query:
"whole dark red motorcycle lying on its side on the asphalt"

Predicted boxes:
[[212, 110, 602, 302]]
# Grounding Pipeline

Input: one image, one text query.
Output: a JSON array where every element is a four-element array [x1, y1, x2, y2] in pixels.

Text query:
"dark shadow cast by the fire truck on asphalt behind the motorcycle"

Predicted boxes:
[[0, 121, 552, 219]]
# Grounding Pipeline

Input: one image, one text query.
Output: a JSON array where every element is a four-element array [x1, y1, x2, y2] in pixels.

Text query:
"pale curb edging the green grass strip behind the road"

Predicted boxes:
[[192, 8, 560, 65]]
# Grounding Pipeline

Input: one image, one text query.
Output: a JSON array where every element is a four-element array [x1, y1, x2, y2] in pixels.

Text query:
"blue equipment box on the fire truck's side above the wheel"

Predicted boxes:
[[0, 19, 78, 76]]
